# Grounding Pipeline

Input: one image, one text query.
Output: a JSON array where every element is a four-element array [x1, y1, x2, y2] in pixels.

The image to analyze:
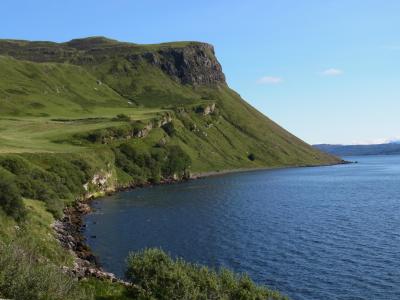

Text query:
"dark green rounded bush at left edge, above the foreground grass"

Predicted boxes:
[[0, 169, 25, 220]]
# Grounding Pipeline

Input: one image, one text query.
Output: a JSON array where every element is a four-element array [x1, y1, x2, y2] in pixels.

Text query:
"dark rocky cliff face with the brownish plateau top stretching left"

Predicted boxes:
[[0, 37, 226, 86]]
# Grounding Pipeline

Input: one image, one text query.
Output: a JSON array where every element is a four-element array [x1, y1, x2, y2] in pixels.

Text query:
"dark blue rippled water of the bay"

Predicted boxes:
[[86, 156, 400, 299]]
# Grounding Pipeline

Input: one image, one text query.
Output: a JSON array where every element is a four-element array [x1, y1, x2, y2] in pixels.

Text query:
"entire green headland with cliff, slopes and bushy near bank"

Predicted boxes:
[[0, 37, 339, 299]]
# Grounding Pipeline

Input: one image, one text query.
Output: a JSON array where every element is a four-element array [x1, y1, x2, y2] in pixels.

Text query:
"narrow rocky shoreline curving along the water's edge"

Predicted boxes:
[[52, 160, 353, 285]]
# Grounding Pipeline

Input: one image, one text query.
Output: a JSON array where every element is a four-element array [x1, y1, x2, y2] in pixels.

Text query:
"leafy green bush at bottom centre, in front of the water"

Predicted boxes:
[[126, 249, 286, 300]]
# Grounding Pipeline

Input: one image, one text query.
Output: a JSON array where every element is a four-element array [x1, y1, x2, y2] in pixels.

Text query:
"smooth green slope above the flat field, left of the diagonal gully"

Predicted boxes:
[[0, 57, 129, 117]]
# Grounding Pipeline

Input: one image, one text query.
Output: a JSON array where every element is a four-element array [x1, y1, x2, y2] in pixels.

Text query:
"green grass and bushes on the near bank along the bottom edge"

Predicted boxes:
[[0, 200, 285, 300]]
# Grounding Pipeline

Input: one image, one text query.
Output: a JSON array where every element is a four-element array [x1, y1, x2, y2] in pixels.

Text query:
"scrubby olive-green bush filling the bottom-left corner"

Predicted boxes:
[[0, 242, 91, 300]]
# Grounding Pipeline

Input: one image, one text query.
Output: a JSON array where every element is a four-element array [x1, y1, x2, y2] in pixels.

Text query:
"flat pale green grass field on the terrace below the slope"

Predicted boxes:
[[0, 108, 163, 153]]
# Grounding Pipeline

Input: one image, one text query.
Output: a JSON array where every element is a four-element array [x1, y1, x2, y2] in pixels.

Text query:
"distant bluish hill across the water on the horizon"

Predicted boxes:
[[313, 143, 400, 156]]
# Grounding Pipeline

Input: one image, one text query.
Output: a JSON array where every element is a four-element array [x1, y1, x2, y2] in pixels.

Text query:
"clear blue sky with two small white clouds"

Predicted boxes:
[[0, 0, 400, 144]]
